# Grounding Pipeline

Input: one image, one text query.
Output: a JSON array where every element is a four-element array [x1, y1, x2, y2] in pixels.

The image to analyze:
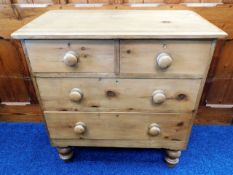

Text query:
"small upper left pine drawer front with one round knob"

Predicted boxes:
[[25, 40, 115, 73]]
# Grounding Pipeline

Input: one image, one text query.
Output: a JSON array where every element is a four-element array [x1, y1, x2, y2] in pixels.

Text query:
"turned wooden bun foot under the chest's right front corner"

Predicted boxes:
[[164, 150, 181, 167]]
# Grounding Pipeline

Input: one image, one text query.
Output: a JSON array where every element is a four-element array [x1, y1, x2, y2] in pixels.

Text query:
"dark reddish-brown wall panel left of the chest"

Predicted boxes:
[[0, 39, 30, 102]]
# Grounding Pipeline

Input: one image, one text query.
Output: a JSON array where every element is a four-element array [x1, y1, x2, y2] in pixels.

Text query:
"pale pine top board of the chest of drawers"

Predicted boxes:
[[12, 10, 227, 39]]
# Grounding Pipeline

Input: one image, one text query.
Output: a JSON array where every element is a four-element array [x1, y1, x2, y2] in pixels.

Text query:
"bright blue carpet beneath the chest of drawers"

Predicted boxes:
[[0, 122, 233, 175]]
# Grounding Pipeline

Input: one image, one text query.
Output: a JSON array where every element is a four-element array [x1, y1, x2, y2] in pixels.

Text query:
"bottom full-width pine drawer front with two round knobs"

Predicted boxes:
[[45, 111, 191, 141]]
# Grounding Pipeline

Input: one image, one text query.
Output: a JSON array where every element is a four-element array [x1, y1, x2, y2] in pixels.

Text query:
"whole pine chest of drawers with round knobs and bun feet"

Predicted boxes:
[[12, 10, 226, 165]]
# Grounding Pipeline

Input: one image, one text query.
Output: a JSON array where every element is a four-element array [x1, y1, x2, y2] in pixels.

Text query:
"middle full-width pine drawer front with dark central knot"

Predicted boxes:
[[37, 78, 201, 112]]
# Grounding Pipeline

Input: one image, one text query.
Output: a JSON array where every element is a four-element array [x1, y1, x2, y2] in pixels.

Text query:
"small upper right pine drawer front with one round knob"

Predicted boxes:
[[120, 40, 212, 78]]
